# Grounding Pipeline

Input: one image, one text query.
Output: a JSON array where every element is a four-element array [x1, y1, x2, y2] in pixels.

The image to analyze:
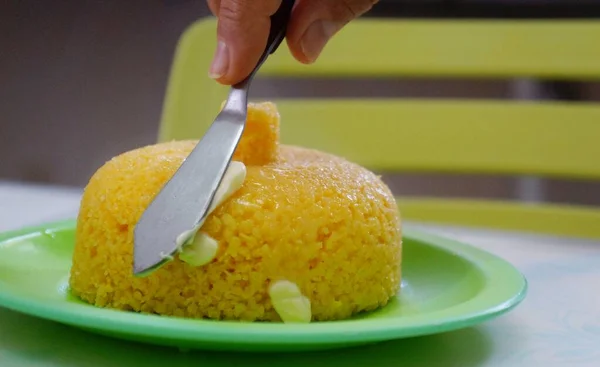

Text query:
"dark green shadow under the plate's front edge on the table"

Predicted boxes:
[[0, 309, 492, 367]]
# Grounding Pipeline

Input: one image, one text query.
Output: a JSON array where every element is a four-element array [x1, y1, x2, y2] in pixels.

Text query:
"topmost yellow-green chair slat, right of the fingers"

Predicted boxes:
[[261, 20, 600, 79]]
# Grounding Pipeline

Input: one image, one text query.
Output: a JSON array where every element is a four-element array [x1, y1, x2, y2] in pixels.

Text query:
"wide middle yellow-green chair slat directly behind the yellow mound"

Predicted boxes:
[[270, 100, 600, 178]]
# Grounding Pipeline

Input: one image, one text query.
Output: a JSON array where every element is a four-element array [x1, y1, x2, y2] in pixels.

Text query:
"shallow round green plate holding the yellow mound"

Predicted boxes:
[[0, 221, 527, 351]]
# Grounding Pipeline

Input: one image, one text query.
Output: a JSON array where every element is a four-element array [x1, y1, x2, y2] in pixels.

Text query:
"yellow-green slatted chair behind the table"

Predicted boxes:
[[159, 18, 600, 238]]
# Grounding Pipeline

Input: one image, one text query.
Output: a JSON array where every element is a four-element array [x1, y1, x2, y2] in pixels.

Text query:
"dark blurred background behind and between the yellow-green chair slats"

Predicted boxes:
[[0, 0, 600, 205]]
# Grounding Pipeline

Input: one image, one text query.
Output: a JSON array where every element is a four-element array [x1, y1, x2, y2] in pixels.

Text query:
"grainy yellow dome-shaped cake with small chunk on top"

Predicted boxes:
[[70, 104, 402, 321]]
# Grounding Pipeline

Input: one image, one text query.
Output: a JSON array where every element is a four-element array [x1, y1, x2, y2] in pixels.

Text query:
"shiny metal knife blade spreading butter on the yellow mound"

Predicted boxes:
[[133, 103, 246, 276]]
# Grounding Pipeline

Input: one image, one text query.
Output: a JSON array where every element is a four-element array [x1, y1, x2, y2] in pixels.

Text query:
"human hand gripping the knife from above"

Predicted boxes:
[[208, 0, 378, 85]]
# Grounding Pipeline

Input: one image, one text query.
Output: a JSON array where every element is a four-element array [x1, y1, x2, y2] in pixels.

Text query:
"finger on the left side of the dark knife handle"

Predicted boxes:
[[209, 0, 281, 85]]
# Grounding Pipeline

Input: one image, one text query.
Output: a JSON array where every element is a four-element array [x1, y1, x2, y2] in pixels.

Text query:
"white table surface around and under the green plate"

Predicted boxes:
[[0, 182, 600, 367]]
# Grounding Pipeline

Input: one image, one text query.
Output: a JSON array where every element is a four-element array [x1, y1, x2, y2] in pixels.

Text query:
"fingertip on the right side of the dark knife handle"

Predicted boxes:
[[287, 0, 378, 64]]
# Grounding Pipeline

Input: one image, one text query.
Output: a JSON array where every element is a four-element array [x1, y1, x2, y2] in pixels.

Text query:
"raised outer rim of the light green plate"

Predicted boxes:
[[0, 219, 528, 346]]
